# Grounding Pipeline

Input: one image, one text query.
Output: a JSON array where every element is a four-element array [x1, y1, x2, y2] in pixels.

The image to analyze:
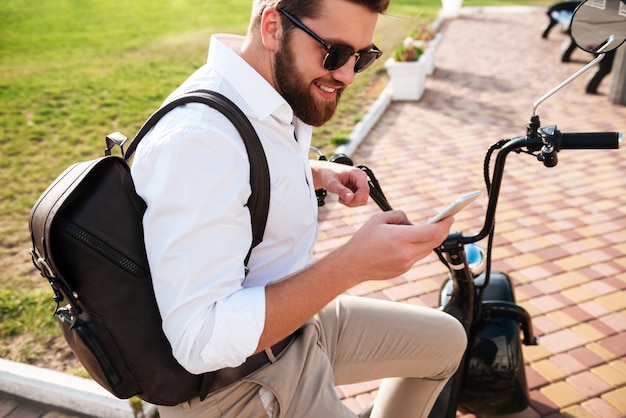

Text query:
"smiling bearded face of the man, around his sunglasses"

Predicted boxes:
[[274, 0, 378, 126]]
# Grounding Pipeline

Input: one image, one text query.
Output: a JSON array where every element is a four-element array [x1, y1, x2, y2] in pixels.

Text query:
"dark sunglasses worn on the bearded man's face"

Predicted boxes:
[[277, 9, 383, 73]]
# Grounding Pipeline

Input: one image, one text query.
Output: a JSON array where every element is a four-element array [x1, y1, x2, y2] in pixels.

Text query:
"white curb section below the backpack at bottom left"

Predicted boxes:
[[0, 358, 156, 418]]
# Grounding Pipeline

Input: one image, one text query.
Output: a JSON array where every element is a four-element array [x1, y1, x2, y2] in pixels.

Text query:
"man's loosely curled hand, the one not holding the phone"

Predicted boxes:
[[311, 160, 370, 207]]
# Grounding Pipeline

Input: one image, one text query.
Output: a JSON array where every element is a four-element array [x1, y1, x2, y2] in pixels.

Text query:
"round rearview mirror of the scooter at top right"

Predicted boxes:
[[570, 0, 626, 54]]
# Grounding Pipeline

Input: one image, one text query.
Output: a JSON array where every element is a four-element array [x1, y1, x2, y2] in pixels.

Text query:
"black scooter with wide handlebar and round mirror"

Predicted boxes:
[[318, 0, 626, 418]]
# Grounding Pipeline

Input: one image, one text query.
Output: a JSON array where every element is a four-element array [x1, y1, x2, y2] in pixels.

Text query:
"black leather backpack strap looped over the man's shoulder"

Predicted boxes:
[[124, 90, 270, 265]]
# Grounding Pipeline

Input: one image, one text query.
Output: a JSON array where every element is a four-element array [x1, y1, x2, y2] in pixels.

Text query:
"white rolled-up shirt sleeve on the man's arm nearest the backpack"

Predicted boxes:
[[132, 104, 265, 374]]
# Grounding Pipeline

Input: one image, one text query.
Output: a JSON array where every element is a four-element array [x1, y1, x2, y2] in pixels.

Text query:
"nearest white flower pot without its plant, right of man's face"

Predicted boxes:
[[385, 54, 426, 100]]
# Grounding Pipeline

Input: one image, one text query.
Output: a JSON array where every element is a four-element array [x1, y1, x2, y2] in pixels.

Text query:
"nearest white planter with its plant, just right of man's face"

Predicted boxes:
[[385, 45, 426, 100]]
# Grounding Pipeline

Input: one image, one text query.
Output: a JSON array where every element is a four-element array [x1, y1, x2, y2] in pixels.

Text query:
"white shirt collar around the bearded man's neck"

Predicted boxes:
[[207, 34, 293, 123]]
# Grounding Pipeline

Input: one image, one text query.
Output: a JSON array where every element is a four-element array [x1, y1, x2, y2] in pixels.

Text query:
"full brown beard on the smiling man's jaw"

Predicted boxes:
[[274, 42, 345, 126]]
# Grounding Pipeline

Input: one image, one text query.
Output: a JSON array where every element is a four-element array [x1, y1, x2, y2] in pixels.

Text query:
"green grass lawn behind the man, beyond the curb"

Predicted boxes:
[[0, 0, 552, 370]]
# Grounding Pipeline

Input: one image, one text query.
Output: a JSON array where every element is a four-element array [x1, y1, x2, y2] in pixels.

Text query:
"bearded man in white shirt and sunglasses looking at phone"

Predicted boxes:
[[132, 0, 466, 418]]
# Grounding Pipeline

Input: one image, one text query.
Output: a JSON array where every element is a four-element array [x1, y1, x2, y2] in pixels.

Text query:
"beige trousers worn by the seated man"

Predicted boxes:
[[159, 296, 466, 418]]
